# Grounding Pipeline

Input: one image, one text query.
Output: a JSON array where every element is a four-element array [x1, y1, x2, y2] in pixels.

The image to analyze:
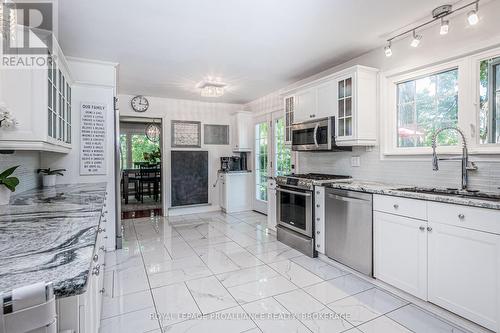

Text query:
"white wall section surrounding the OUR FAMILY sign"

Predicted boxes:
[[41, 58, 117, 250]]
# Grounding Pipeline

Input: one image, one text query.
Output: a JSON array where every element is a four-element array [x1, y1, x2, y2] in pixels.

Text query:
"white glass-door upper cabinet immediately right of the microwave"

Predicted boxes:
[[335, 66, 378, 146]]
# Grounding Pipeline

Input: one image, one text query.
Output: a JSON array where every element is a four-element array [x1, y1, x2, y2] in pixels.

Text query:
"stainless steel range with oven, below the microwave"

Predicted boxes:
[[276, 173, 351, 257]]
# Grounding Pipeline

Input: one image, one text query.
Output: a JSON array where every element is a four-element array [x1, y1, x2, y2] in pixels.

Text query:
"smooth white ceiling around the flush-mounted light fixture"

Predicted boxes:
[[59, 0, 450, 103]]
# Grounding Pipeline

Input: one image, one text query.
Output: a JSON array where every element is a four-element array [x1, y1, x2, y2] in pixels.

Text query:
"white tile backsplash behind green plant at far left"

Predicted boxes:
[[0, 151, 41, 194]]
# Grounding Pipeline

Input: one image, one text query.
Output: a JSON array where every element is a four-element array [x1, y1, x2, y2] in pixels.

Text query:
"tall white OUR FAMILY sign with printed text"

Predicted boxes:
[[80, 103, 106, 175]]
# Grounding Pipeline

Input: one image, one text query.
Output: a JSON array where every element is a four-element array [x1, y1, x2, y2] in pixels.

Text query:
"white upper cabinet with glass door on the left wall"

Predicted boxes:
[[0, 29, 73, 153]]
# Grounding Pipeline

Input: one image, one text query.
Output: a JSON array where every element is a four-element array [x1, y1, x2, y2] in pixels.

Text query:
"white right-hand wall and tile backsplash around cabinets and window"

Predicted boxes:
[[245, 0, 500, 191]]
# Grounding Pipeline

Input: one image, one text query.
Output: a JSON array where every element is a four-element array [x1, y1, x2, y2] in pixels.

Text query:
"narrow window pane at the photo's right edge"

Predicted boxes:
[[479, 57, 500, 144]]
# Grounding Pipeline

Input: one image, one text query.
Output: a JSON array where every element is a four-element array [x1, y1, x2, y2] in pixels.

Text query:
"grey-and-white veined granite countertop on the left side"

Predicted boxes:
[[0, 183, 106, 297]]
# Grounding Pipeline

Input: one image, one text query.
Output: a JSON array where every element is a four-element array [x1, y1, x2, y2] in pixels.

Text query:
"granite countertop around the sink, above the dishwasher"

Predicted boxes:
[[325, 180, 500, 209]]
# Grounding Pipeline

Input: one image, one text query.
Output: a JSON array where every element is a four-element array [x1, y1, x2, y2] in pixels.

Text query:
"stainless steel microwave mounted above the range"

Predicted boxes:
[[292, 117, 352, 151]]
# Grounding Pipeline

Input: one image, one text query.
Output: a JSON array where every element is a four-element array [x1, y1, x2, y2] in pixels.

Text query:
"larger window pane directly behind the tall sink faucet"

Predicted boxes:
[[397, 69, 458, 147]]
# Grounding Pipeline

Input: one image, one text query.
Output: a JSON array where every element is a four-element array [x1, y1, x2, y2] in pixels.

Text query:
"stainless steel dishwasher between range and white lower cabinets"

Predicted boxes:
[[325, 188, 373, 276]]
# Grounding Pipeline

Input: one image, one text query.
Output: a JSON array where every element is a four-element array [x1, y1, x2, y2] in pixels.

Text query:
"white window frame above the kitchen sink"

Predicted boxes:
[[379, 47, 500, 159]]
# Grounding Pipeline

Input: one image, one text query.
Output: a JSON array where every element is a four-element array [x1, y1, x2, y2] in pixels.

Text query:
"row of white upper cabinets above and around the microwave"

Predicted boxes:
[[284, 66, 378, 146]]
